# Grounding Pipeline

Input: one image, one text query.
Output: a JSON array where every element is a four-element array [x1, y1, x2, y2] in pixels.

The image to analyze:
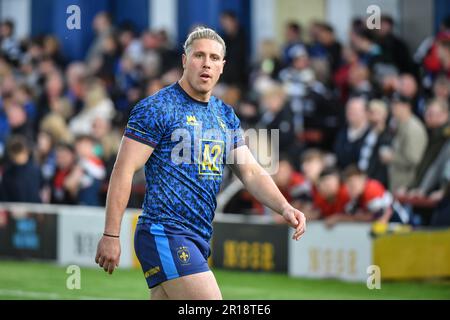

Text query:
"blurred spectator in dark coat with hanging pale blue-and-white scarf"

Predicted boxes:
[[358, 100, 392, 188]]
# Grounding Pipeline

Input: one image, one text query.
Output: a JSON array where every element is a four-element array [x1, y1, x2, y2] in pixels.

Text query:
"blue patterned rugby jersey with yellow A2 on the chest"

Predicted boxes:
[[124, 83, 244, 241]]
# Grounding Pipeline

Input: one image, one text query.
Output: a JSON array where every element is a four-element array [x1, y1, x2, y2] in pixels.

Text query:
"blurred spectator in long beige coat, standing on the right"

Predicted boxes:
[[381, 94, 428, 192]]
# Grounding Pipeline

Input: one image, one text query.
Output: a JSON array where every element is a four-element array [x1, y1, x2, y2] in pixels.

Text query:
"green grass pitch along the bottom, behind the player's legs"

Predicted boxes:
[[0, 260, 450, 300]]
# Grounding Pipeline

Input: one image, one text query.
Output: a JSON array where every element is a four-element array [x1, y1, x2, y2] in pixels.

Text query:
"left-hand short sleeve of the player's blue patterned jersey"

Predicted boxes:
[[124, 99, 167, 148]]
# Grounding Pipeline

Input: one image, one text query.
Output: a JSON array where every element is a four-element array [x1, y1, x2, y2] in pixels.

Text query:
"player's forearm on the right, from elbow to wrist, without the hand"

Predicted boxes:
[[241, 165, 290, 214]]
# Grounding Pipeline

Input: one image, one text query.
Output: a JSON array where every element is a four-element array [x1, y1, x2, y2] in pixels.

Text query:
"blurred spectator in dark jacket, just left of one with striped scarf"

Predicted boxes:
[[334, 97, 370, 169]]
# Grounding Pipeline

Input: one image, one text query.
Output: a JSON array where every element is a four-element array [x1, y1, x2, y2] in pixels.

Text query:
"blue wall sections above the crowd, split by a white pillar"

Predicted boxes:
[[31, 0, 251, 59]]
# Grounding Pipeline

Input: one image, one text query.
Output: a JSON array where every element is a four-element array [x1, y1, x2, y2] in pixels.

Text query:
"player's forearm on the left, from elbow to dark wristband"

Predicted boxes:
[[105, 167, 133, 235]]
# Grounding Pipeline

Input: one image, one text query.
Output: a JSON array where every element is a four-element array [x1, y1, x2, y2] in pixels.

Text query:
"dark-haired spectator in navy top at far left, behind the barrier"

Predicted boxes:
[[0, 136, 41, 203]]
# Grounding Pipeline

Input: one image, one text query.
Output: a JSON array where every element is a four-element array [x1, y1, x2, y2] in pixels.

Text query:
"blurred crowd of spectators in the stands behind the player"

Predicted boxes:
[[0, 12, 450, 227]]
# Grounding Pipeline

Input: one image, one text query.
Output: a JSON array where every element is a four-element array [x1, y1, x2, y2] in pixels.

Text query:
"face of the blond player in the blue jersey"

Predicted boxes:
[[183, 39, 225, 94]]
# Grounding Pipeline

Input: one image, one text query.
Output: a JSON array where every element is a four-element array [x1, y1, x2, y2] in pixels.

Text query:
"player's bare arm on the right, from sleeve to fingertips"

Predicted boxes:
[[230, 145, 305, 240]]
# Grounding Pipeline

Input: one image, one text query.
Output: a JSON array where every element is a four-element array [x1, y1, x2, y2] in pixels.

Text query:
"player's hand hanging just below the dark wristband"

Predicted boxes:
[[95, 236, 120, 274]]
